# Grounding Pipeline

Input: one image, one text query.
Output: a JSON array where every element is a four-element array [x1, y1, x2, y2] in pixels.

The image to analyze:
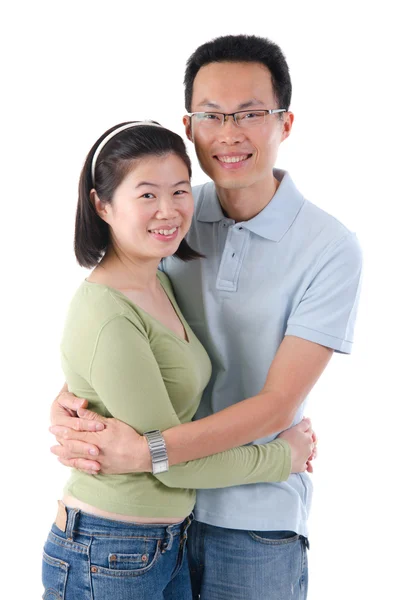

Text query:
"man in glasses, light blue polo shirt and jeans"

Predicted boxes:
[[48, 36, 361, 600]]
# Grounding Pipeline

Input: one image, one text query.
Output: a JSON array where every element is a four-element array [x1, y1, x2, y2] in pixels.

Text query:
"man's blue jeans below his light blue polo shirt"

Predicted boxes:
[[188, 521, 308, 600]]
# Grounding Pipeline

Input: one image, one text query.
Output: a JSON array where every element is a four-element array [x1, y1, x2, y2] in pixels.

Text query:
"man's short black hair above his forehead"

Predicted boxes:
[[184, 35, 292, 112]]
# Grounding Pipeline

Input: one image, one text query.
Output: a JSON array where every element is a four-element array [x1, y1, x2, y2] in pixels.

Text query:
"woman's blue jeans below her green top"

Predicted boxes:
[[43, 509, 192, 600]]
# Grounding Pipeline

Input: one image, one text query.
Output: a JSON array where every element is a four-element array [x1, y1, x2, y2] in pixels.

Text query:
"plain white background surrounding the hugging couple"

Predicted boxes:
[[0, 0, 397, 600]]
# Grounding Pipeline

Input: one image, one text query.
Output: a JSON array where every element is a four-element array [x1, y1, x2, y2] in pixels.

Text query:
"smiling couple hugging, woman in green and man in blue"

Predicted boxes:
[[43, 35, 361, 600]]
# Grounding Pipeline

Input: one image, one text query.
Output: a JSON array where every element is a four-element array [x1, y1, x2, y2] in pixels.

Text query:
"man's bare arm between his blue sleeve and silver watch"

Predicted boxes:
[[163, 336, 333, 465]]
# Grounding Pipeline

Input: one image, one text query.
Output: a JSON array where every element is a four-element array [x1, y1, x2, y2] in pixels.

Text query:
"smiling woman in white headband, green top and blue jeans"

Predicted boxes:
[[43, 122, 312, 600]]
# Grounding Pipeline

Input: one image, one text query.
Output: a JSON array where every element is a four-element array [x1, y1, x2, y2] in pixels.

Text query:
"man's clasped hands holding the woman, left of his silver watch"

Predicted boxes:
[[50, 391, 151, 474]]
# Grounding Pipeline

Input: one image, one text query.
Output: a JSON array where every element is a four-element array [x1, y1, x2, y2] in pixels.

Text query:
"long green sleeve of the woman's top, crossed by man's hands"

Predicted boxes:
[[90, 316, 291, 489]]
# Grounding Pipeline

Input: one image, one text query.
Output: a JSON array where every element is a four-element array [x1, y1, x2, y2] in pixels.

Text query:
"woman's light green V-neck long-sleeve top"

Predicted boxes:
[[61, 272, 291, 517]]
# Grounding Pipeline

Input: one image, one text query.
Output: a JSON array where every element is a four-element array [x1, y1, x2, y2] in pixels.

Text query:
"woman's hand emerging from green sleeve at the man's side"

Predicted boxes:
[[277, 418, 317, 473]]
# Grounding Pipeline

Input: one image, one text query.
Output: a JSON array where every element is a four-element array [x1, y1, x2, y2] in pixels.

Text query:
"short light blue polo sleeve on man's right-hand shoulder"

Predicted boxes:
[[285, 233, 362, 354]]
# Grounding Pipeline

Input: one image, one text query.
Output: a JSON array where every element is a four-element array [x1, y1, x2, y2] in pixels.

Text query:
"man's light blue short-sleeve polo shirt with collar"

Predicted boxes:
[[164, 170, 361, 536]]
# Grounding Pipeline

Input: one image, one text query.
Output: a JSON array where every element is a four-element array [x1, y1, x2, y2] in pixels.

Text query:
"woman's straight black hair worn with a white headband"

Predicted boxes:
[[74, 121, 202, 267]]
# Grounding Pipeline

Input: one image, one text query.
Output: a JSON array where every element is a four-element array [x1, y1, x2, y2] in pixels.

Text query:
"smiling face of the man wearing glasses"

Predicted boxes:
[[184, 62, 293, 189]]
